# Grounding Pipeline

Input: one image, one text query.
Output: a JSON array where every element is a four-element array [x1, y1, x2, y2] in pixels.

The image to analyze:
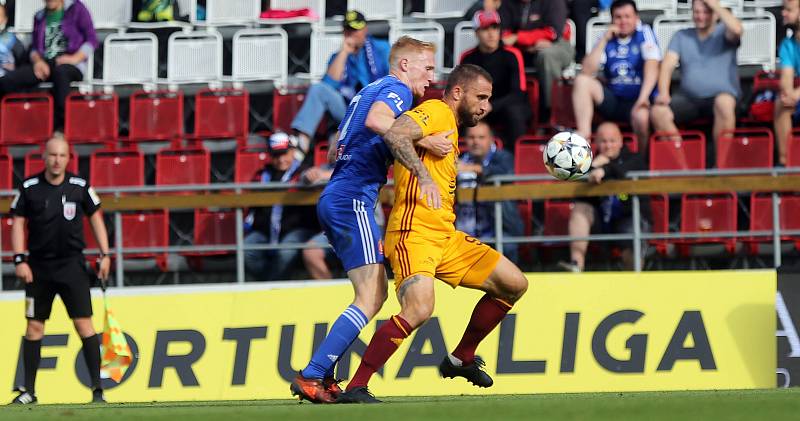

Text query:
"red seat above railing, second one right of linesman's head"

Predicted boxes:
[[156, 147, 211, 186]]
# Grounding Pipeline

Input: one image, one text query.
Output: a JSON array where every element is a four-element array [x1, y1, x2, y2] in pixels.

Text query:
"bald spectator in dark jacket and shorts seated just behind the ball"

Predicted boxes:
[[559, 122, 647, 272]]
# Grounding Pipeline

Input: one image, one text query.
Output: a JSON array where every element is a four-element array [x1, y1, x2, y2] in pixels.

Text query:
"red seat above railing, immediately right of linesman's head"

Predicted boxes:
[[89, 149, 144, 187]]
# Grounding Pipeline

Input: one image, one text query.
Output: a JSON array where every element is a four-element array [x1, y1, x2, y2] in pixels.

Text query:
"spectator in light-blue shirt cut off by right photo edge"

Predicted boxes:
[[775, 0, 800, 165]]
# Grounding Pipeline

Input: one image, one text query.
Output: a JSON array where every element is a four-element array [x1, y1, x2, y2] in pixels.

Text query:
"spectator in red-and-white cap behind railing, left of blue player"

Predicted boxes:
[[244, 132, 322, 281]]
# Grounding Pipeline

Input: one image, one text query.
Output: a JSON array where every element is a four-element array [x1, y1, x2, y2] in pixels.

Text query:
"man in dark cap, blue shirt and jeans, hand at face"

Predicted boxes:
[[291, 10, 390, 159]]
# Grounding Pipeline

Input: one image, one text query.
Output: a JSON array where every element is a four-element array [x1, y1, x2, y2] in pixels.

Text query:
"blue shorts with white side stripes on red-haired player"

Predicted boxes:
[[317, 195, 383, 271]]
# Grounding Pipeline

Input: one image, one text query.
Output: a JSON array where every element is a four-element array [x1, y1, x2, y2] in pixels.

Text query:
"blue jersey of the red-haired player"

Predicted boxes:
[[322, 75, 413, 204]]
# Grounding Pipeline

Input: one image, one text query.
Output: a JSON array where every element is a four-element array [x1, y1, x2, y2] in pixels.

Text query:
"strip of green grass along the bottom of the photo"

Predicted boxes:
[[0, 388, 800, 421]]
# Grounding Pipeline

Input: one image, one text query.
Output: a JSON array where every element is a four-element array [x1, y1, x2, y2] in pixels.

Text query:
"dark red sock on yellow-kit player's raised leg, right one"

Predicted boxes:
[[453, 294, 511, 365]]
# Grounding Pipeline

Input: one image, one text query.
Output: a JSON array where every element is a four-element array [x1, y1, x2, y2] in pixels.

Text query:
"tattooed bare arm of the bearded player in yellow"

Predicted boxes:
[[383, 115, 442, 209]]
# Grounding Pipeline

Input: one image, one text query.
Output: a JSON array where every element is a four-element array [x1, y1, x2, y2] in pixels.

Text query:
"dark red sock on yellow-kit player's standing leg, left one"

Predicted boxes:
[[347, 316, 413, 391]]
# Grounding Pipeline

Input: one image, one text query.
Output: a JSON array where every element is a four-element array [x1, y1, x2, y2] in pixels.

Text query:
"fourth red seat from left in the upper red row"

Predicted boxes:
[[194, 89, 250, 144]]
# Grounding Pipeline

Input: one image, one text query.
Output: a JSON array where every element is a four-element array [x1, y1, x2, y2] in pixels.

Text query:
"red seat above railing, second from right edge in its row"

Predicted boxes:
[[716, 128, 775, 169]]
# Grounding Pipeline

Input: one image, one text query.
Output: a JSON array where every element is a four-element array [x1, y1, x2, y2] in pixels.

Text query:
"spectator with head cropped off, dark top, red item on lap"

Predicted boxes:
[[500, 0, 575, 112]]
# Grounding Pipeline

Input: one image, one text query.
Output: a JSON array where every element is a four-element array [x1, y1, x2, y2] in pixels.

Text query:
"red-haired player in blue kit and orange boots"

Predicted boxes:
[[290, 37, 452, 403]]
